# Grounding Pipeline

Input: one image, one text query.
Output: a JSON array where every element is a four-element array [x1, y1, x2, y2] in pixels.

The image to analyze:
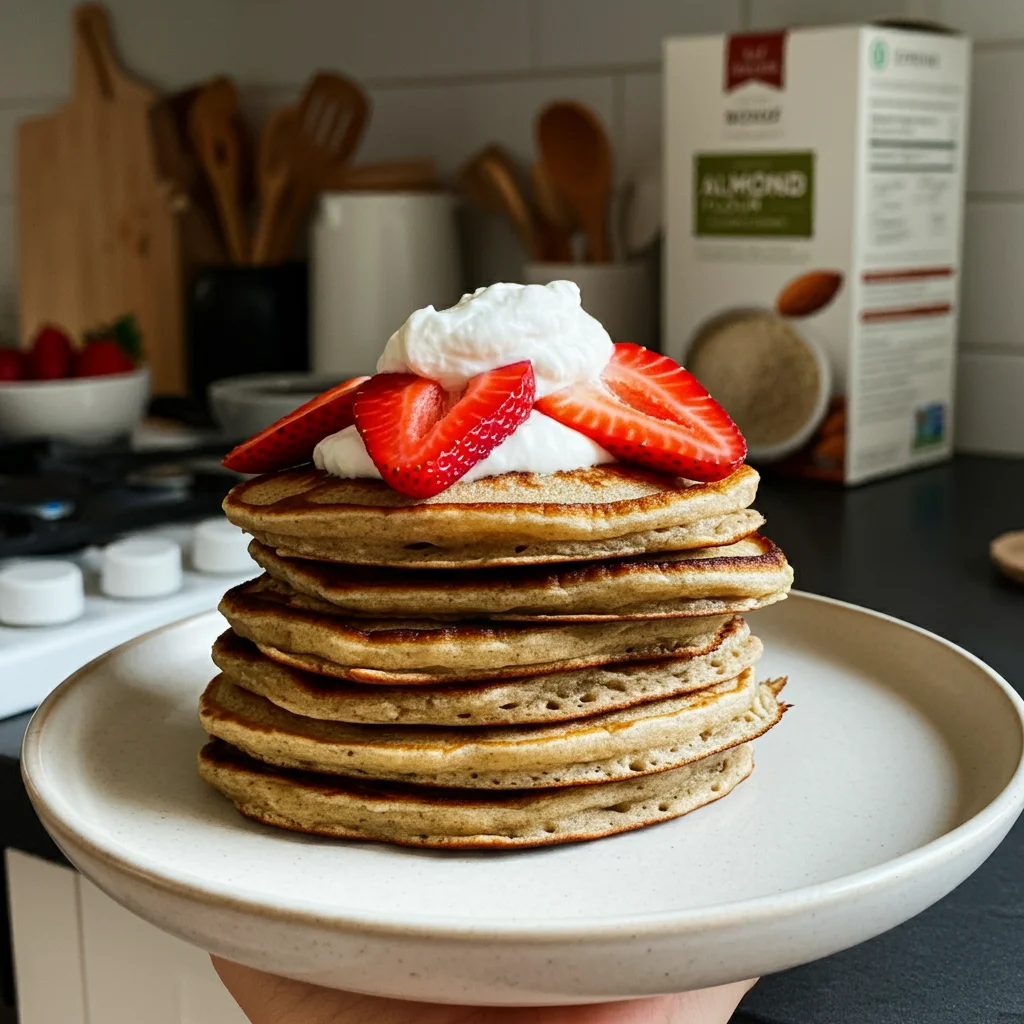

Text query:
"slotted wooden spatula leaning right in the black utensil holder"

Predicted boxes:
[[275, 72, 370, 259]]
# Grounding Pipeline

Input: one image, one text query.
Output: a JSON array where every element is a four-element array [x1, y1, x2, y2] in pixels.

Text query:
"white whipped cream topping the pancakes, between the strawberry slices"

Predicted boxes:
[[313, 281, 614, 482]]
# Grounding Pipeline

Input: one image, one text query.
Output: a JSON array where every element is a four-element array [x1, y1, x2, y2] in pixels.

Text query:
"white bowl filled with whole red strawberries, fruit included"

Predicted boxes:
[[0, 316, 150, 444]]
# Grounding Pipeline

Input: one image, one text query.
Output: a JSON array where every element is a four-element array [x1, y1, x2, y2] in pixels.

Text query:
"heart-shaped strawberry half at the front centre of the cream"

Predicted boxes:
[[355, 359, 536, 498]]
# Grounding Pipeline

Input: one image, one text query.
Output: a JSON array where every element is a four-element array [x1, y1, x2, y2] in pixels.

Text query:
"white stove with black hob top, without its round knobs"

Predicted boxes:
[[0, 431, 259, 719]]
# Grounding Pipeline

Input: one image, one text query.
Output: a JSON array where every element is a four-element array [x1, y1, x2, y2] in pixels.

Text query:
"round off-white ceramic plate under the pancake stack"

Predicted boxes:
[[24, 594, 1024, 1005]]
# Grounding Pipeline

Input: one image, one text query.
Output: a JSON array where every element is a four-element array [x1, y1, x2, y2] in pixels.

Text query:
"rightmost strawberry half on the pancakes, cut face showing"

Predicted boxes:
[[537, 343, 746, 480]]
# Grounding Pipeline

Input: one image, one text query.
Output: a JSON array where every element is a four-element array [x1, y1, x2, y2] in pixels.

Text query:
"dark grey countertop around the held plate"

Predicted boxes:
[[0, 458, 1024, 1024]]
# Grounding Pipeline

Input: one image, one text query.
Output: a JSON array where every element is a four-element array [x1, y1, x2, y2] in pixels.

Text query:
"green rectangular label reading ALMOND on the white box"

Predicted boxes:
[[693, 152, 814, 239]]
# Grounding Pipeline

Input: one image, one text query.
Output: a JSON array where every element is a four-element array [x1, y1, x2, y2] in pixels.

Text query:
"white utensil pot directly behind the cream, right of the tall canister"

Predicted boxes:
[[522, 260, 657, 348]]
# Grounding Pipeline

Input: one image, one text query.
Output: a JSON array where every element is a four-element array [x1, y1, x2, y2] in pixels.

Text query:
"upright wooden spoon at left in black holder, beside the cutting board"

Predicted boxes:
[[188, 78, 249, 263]]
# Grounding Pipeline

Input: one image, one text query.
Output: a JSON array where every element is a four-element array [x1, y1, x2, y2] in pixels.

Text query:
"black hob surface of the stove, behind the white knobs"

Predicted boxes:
[[0, 435, 239, 558]]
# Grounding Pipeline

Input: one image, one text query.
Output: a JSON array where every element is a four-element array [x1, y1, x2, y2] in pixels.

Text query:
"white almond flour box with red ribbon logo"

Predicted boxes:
[[664, 26, 970, 483]]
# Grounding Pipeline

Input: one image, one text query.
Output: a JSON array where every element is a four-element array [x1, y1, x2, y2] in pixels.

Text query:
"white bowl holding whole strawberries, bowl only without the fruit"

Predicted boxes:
[[0, 367, 150, 444]]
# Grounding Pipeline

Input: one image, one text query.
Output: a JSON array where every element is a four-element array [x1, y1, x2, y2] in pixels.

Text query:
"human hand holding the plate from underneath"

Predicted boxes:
[[213, 956, 754, 1024]]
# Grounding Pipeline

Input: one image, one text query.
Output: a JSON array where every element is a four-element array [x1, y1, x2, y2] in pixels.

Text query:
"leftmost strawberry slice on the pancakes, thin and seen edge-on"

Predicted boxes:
[[222, 377, 369, 473]]
